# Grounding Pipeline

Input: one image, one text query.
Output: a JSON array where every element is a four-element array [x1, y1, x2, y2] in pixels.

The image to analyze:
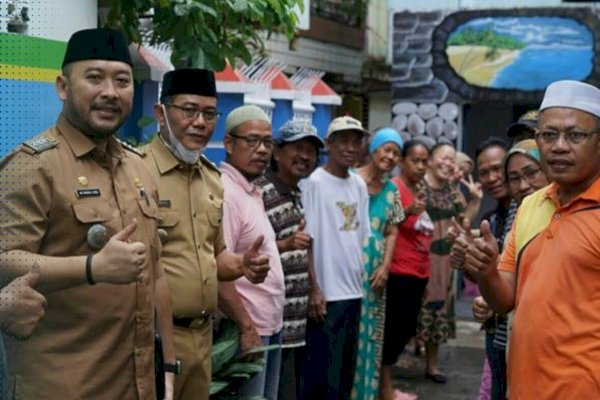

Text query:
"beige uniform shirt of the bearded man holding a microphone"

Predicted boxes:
[[0, 116, 161, 400]]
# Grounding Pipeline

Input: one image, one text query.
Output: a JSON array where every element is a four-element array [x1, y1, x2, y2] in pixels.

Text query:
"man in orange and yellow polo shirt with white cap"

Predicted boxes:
[[466, 81, 600, 400]]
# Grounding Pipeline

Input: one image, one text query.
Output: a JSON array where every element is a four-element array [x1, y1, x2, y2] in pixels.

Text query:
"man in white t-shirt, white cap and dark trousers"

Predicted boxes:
[[302, 117, 370, 399]]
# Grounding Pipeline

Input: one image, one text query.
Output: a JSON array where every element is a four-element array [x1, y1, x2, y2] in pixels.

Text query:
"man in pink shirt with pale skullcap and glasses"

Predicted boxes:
[[219, 106, 285, 400]]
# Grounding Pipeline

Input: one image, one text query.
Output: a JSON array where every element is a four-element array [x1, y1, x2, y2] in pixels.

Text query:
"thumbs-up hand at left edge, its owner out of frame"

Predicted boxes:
[[0, 261, 46, 339]]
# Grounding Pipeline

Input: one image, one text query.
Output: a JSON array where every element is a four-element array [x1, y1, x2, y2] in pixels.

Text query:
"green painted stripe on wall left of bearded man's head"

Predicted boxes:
[[0, 33, 67, 69]]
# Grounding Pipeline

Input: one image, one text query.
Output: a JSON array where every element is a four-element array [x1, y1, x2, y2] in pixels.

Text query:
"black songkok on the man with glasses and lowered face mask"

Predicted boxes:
[[160, 68, 217, 102]]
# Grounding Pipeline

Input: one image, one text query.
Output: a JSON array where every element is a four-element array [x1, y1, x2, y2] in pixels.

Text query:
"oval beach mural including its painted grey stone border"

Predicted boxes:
[[432, 8, 600, 104]]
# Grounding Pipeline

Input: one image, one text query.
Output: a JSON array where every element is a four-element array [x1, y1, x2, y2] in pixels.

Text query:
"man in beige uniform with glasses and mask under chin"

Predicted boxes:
[[144, 69, 268, 399]]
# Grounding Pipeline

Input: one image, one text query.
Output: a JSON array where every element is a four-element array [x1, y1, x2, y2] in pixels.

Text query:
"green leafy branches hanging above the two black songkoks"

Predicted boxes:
[[100, 0, 304, 71]]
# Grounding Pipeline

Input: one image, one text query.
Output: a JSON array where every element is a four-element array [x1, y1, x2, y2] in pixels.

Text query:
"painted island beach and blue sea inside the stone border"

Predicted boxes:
[[446, 17, 594, 90]]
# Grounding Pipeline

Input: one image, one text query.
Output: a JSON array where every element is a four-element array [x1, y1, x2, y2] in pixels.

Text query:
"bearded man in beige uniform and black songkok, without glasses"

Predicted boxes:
[[0, 29, 175, 400]]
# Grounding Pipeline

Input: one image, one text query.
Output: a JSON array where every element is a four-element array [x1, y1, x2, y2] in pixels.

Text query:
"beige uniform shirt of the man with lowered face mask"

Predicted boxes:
[[144, 135, 225, 318]]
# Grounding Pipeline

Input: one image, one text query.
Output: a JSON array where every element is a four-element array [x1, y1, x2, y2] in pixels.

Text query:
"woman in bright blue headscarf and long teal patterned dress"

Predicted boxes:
[[352, 128, 404, 400]]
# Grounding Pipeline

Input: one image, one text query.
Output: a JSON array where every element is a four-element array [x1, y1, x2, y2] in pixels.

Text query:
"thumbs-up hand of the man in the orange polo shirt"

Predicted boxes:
[[465, 221, 499, 278]]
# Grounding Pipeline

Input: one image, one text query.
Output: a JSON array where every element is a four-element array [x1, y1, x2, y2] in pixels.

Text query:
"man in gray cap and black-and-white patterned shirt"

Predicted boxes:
[[255, 120, 324, 399]]
